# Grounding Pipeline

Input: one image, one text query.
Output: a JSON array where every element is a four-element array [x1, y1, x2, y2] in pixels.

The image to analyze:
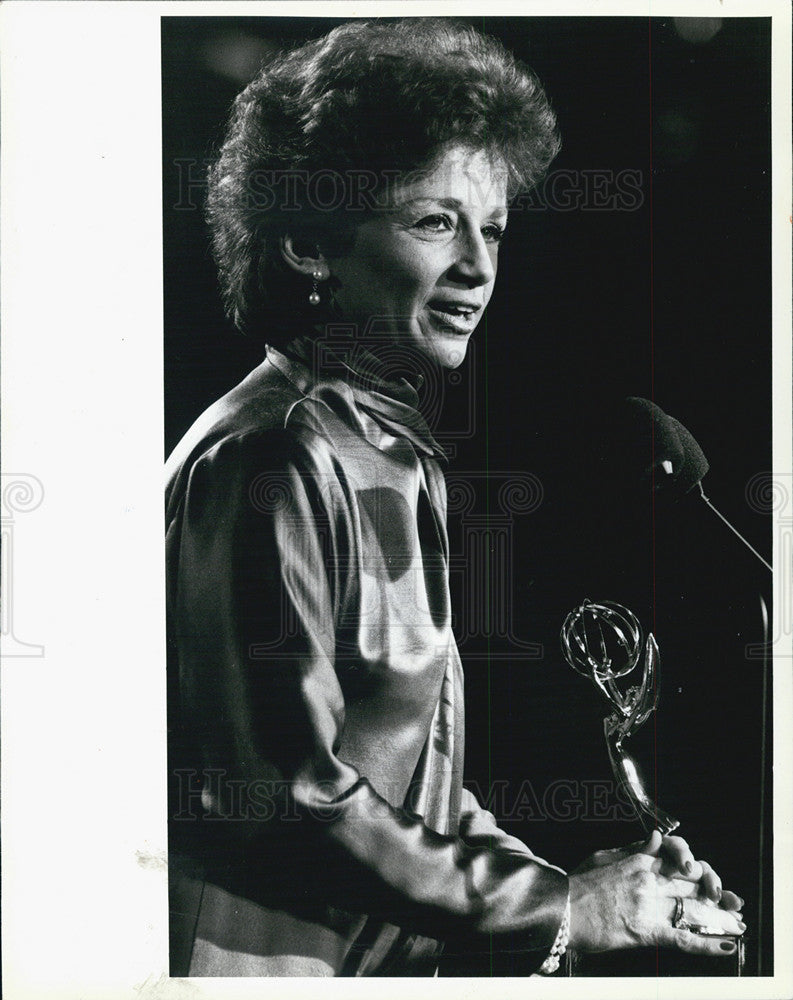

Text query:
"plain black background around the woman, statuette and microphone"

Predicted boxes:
[[162, 17, 773, 975]]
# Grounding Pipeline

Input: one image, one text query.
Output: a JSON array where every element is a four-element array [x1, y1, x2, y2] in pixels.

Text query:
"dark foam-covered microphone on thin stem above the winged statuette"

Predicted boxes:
[[616, 396, 773, 572]]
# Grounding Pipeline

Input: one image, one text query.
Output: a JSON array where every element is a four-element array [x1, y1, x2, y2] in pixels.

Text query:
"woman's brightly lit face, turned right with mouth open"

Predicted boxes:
[[328, 146, 507, 368]]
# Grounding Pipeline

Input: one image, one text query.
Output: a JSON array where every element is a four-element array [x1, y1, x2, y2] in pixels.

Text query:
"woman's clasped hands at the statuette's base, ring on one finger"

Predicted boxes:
[[570, 831, 746, 955]]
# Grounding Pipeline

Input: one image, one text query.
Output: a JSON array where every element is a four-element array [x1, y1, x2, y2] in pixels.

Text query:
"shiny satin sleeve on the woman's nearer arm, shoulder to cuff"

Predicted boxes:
[[169, 432, 568, 965]]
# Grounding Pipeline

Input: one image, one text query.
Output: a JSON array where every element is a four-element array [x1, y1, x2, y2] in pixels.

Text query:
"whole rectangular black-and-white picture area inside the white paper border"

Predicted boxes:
[[163, 17, 773, 976]]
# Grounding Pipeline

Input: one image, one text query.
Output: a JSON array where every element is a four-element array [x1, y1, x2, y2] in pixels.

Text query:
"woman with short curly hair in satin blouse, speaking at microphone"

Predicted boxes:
[[167, 20, 743, 976]]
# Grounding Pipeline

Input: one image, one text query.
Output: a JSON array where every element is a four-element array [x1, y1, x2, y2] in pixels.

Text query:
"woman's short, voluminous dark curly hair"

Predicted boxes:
[[207, 18, 560, 345]]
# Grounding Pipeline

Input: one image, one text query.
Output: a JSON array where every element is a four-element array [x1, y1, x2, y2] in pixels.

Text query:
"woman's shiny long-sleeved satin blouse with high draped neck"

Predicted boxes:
[[166, 341, 568, 976]]
